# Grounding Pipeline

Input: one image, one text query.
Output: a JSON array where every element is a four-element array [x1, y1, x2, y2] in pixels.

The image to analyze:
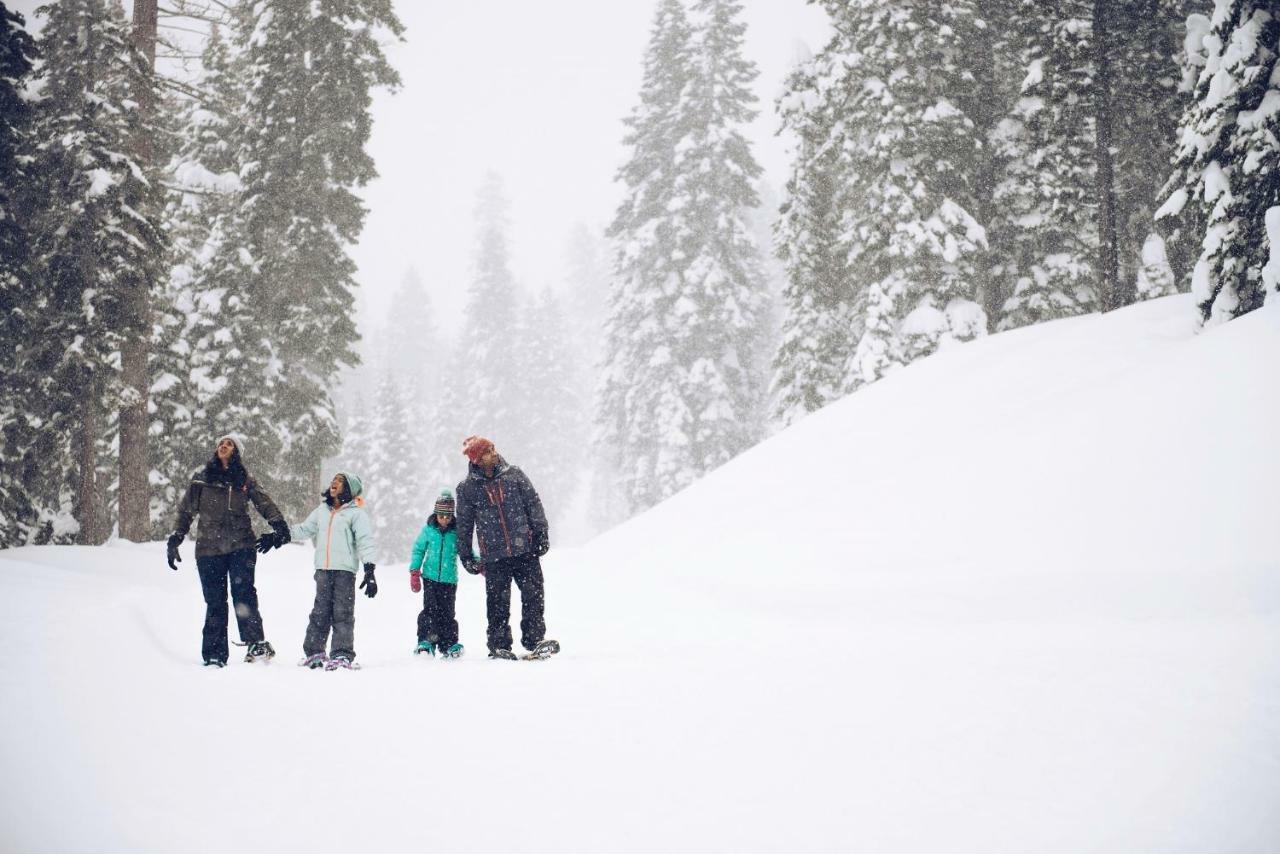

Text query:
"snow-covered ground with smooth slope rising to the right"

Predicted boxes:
[[0, 297, 1280, 854]]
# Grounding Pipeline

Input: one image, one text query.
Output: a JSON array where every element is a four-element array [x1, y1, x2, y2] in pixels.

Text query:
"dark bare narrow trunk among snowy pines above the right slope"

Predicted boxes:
[[1093, 0, 1133, 311]]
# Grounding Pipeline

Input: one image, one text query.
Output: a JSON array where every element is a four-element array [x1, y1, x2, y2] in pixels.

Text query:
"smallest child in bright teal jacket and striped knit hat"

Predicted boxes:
[[408, 489, 462, 658]]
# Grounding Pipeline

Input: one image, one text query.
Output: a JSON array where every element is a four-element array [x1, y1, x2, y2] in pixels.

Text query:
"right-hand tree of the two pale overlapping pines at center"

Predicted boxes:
[[659, 0, 768, 481]]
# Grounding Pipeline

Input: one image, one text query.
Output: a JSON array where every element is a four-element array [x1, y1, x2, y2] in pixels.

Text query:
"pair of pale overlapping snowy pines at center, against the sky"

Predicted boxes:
[[598, 0, 765, 510]]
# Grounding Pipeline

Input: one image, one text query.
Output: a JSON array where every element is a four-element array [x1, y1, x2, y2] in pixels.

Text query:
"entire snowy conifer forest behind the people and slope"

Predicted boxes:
[[0, 0, 1280, 561]]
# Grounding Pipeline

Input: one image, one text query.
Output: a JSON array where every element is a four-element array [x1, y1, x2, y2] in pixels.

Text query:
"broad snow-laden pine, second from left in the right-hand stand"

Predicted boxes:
[[824, 0, 987, 391]]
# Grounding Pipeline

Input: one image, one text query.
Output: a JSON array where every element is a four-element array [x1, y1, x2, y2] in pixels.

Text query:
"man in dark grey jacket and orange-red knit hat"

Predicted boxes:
[[457, 435, 559, 658]]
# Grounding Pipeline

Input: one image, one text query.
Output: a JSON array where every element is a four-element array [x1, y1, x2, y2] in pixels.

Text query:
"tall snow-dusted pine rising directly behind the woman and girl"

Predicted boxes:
[[238, 0, 403, 517]]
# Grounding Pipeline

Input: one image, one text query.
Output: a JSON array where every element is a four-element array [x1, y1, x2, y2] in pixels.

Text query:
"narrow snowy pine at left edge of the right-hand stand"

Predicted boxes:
[[772, 43, 865, 426]]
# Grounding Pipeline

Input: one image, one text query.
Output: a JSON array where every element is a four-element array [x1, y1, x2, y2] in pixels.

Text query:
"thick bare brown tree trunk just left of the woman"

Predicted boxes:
[[119, 0, 156, 542]]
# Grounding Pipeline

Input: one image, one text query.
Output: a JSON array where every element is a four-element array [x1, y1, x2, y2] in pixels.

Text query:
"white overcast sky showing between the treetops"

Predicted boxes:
[[10, 0, 827, 332]]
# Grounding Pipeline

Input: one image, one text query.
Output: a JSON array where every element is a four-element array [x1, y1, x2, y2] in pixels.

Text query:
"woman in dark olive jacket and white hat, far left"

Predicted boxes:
[[169, 434, 289, 667]]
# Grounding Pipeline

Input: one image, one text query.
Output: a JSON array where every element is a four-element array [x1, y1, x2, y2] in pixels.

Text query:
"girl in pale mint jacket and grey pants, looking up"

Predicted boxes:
[[289, 471, 378, 670]]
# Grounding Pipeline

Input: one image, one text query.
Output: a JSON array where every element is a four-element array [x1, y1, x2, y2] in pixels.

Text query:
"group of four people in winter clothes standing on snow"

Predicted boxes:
[[168, 434, 559, 670]]
